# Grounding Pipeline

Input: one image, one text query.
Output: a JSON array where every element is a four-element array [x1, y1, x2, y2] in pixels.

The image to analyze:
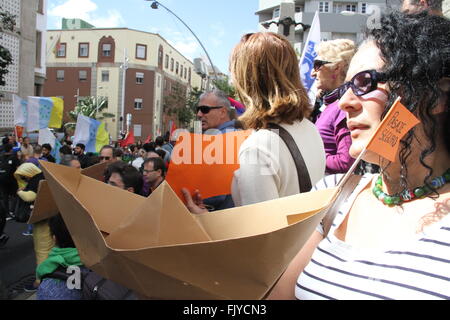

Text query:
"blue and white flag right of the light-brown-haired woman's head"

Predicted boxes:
[[300, 11, 320, 104]]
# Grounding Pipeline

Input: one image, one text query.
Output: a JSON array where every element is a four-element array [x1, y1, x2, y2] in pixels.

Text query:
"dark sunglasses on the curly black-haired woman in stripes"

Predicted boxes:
[[338, 70, 387, 99]]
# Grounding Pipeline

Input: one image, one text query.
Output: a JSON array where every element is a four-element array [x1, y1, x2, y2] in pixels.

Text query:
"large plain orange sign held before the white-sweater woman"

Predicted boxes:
[[166, 131, 251, 201]]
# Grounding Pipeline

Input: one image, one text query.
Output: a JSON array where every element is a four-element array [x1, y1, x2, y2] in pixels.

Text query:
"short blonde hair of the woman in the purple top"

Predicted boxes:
[[317, 39, 356, 82]]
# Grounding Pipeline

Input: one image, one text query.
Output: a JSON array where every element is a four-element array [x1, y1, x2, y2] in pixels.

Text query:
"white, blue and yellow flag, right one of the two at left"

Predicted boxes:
[[73, 115, 109, 152]]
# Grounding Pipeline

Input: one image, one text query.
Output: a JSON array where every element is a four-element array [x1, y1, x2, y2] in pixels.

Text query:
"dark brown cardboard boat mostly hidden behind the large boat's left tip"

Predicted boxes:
[[27, 162, 109, 224]]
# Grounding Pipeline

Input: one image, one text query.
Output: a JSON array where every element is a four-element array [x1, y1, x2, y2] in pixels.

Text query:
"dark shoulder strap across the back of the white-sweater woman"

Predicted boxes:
[[268, 123, 312, 193]]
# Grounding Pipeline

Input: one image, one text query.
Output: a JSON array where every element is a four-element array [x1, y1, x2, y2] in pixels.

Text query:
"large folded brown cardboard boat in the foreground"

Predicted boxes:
[[42, 163, 337, 299]]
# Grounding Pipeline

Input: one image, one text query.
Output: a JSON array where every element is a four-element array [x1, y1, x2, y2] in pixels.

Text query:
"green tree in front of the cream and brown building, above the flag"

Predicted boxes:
[[65, 97, 114, 127]]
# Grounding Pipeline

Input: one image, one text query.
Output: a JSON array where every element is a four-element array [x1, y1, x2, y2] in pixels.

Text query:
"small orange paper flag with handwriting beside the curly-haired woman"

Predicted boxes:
[[366, 98, 420, 162]]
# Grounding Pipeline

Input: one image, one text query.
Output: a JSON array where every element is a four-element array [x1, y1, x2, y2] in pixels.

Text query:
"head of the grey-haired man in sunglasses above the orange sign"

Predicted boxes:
[[197, 89, 236, 134]]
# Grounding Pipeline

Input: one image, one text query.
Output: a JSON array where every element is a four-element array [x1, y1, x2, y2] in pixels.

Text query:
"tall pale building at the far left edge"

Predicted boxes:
[[0, 0, 47, 130]]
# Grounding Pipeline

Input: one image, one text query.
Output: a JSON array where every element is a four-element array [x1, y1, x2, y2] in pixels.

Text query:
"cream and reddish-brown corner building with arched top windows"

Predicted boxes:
[[44, 21, 201, 140]]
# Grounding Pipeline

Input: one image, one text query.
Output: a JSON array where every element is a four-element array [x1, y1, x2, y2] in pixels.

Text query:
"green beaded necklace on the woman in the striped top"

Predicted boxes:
[[372, 168, 450, 206]]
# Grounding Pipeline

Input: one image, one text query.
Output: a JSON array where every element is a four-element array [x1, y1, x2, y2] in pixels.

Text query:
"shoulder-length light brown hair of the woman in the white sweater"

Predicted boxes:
[[230, 32, 310, 130]]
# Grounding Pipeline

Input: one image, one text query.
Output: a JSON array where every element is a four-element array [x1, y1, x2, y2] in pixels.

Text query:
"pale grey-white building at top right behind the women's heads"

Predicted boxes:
[[256, 0, 386, 53]]
